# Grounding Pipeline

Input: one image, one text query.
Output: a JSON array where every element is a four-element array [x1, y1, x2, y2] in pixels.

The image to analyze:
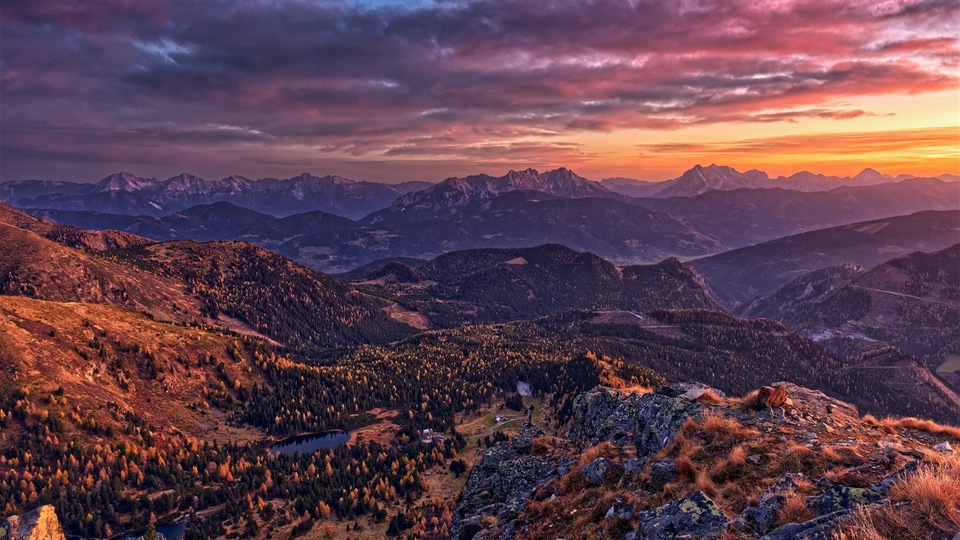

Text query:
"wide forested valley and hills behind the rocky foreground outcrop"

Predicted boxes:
[[0, 170, 960, 539]]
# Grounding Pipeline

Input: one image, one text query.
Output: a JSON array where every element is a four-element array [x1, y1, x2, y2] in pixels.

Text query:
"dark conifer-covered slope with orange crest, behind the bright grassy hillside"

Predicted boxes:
[[108, 241, 413, 350]]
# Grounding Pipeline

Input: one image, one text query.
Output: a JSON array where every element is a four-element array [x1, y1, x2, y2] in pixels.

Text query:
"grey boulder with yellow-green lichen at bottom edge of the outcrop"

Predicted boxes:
[[632, 491, 727, 540]]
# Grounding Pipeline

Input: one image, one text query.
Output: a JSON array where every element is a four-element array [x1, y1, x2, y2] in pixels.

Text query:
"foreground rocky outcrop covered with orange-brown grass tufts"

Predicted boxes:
[[453, 382, 960, 540]]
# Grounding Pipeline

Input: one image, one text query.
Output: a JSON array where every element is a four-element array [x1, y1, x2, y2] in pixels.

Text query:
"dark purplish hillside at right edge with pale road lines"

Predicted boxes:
[[740, 244, 960, 389]]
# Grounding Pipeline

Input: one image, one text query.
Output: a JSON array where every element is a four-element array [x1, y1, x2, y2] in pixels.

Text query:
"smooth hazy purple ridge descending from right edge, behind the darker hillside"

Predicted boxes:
[[691, 211, 960, 307]]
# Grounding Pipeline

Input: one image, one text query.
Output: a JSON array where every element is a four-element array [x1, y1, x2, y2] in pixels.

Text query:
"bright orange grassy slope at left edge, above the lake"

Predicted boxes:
[[0, 296, 259, 447]]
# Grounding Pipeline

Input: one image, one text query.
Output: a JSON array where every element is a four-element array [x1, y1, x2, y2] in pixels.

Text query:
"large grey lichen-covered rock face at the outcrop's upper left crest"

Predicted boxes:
[[565, 387, 703, 458]]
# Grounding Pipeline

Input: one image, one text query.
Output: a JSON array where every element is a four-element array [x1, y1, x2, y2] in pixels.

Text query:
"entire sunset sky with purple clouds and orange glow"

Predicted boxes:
[[0, 0, 960, 182]]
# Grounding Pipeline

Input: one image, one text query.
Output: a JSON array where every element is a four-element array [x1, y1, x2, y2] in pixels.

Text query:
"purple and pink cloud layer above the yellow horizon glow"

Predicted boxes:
[[0, 0, 958, 181]]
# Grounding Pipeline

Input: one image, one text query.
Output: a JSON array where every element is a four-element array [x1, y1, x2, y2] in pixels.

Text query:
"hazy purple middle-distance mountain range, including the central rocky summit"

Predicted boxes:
[[24, 170, 960, 274]]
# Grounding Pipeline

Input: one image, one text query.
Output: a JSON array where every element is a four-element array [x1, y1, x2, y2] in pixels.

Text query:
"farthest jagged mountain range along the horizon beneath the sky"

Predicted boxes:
[[0, 165, 960, 222]]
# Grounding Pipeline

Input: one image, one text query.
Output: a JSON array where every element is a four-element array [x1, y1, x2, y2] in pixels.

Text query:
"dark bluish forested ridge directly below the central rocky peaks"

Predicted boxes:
[[278, 191, 724, 272]]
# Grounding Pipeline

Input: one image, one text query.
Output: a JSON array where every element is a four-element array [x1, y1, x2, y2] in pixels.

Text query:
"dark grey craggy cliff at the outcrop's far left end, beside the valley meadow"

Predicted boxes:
[[452, 442, 559, 539]]
